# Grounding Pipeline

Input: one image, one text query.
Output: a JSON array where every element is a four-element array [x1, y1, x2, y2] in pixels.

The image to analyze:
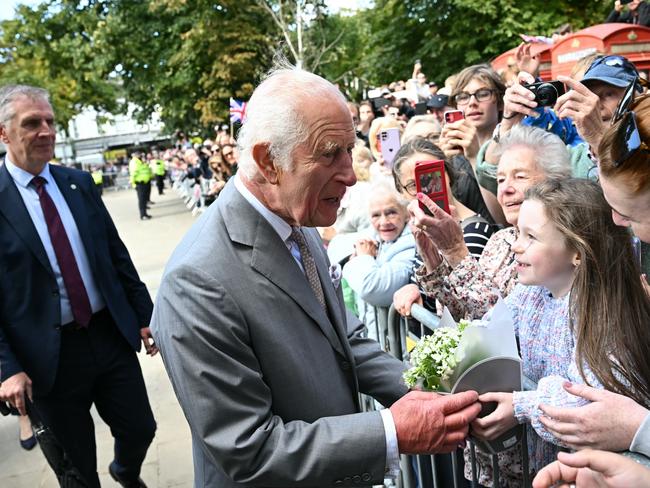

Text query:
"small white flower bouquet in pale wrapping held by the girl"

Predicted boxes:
[[404, 300, 522, 452]]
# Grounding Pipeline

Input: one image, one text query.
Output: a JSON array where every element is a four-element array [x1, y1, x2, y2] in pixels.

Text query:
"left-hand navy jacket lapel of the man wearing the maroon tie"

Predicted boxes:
[[0, 164, 54, 278]]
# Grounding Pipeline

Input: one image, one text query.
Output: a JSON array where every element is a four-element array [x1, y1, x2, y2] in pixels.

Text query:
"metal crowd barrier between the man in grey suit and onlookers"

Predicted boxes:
[[361, 304, 536, 488]]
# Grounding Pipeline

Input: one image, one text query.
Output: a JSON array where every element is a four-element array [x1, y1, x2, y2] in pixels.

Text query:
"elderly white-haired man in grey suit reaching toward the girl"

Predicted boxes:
[[152, 68, 480, 488]]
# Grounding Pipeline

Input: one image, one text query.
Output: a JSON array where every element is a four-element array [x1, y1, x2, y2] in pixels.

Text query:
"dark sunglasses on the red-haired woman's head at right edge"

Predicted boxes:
[[612, 78, 650, 168]]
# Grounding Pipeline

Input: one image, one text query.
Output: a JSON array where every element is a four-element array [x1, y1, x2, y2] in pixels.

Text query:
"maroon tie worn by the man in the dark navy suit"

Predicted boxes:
[[31, 176, 93, 327]]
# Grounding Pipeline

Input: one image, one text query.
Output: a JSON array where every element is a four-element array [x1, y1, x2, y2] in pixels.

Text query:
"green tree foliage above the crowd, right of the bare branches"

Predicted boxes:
[[363, 0, 613, 84]]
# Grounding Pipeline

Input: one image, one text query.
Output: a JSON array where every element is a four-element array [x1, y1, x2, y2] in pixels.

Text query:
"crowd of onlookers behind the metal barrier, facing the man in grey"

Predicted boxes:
[[147, 46, 650, 487]]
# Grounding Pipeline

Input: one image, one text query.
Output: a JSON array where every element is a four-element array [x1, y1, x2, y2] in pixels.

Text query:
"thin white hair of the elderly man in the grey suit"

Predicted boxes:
[[237, 58, 346, 178]]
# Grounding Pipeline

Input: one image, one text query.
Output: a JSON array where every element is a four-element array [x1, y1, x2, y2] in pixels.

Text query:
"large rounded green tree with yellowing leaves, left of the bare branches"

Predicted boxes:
[[85, 0, 274, 130]]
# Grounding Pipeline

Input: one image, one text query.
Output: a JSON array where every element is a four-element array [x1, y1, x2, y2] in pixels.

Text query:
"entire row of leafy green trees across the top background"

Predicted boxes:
[[0, 0, 611, 131]]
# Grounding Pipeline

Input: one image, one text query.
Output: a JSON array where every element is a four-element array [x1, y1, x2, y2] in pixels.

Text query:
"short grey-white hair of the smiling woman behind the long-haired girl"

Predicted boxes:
[[498, 124, 571, 179]]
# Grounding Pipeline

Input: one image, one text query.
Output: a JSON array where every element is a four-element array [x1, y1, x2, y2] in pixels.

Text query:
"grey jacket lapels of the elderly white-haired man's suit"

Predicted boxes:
[[219, 184, 347, 357]]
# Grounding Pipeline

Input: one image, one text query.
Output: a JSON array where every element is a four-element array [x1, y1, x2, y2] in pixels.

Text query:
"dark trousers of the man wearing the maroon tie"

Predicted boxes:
[[34, 310, 156, 488]]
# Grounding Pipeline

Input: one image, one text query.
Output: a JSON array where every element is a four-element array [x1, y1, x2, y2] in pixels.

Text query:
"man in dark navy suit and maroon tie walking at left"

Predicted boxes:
[[0, 85, 157, 487]]
